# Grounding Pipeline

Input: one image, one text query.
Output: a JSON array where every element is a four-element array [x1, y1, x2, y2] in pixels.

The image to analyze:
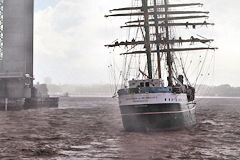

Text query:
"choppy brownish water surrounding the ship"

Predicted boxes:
[[0, 98, 240, 160]]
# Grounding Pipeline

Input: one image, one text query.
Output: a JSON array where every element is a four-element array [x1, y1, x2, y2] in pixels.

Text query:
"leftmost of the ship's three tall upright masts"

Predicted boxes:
[[142, 0, 152, 79]]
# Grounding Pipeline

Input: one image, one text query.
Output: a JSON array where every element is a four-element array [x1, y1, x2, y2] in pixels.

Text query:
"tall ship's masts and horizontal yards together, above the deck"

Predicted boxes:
[[105, 0, 217, 87]]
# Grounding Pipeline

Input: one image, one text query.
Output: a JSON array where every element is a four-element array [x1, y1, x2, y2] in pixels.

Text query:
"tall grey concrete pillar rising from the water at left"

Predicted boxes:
[[0, 0, 34, 98]]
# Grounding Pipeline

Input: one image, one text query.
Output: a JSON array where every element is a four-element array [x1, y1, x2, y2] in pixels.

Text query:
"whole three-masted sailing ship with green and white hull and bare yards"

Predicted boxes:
[[105, 0, 217, 131]]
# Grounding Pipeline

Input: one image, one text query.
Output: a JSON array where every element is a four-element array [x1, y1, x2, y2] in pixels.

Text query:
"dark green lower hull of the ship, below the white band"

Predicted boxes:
[[120, 103, 196, 131]]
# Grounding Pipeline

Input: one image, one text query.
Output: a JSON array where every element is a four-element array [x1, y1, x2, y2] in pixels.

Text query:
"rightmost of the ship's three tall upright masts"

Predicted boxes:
[[164, 0, 173, 86]]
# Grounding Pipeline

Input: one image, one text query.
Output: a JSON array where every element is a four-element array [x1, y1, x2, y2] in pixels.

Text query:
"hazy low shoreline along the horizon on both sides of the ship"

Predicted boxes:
[[45, 84, 240, 99]]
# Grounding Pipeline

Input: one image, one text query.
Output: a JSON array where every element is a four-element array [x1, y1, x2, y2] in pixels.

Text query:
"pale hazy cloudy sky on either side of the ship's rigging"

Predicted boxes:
[[34, 0, 240, 86]]
